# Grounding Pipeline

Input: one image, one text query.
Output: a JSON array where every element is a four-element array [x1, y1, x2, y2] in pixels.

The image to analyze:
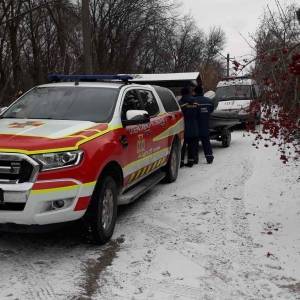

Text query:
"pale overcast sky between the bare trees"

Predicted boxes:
[[181, 0, 298, 57]]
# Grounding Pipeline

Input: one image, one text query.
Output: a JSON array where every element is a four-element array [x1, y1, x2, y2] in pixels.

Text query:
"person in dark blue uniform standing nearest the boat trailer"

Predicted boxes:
[[194, 86, 214, 164]]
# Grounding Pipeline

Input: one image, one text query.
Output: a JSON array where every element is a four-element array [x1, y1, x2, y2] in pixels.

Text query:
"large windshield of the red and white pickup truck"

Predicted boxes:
[[1, 86, 119, 123]]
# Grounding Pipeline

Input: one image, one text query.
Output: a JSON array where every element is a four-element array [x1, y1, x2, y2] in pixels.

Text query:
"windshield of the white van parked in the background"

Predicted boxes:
[[216, 85, 252, 101]]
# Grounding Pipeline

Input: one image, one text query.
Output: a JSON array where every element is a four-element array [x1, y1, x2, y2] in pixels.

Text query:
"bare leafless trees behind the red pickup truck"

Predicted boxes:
[[0, 0, 223, 105]]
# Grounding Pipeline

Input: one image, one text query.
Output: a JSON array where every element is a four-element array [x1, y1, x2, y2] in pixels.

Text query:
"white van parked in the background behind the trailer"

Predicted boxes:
[[216, 77, 261, 123]]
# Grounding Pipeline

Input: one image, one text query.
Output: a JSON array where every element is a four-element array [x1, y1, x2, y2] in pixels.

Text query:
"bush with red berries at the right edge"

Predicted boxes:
[[232, 6, 300, 164]]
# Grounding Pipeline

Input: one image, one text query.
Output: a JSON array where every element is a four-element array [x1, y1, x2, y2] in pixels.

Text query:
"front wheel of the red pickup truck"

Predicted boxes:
[[86, 175, 118, 245]]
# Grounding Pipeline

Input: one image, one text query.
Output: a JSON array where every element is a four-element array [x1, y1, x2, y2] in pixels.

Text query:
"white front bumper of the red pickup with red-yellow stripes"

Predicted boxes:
[[0, 179, 95, 225]]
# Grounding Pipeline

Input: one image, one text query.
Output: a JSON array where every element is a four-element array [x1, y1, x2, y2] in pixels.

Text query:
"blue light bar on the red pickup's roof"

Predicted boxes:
[[48, 74, 133, 82]]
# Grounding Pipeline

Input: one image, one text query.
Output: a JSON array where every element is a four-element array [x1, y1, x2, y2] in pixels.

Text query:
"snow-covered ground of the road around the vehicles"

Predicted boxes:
[[0, 132, 300, 300]]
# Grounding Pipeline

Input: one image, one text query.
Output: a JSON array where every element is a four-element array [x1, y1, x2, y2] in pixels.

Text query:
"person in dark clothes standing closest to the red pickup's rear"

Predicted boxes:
[[179, 87, 199, 167]]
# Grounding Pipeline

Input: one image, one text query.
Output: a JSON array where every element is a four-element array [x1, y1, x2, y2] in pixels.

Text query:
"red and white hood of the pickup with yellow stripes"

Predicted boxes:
[[0, 119, 108, 154]]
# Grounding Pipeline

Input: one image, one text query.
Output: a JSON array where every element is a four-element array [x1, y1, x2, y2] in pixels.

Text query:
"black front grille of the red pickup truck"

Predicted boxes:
[[0, 153, 39, 184]]
